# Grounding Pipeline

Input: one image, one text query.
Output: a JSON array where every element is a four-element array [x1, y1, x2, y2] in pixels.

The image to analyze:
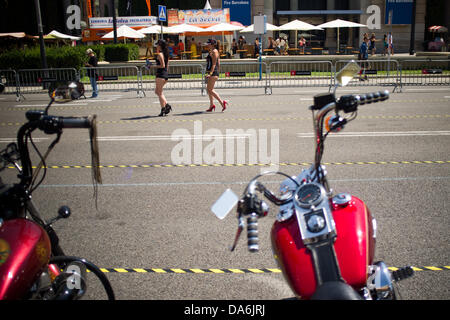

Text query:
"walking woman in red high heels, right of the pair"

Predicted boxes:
[[206, 39, 228, 112]]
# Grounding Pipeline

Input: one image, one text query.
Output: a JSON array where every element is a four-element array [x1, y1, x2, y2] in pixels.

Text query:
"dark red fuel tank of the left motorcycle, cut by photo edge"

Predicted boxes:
[[0, 219, 51, 300]]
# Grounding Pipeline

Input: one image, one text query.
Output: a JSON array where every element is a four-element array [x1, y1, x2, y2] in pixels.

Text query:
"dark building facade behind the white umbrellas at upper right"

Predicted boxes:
[[210, 0, 450, 52]]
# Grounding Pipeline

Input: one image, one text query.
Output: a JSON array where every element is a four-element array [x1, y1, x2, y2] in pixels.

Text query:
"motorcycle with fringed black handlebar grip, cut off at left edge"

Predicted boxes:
[[0, 88, 114, 300]]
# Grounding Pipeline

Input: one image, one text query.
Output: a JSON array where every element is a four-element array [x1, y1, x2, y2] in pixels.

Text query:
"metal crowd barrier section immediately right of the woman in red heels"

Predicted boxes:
[[212, 60, 272, 94]]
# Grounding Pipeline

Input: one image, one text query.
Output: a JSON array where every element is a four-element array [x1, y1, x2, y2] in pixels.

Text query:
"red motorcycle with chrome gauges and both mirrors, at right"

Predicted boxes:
[[211, 63, 413, 300]]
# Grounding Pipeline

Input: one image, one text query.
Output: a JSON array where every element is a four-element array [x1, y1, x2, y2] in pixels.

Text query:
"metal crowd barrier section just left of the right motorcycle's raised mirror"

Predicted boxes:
[[269, 61, 334, 89]]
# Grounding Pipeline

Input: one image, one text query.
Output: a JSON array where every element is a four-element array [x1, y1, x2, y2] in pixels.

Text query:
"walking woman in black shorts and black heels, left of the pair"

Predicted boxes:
[[151, 39, 172, 117]]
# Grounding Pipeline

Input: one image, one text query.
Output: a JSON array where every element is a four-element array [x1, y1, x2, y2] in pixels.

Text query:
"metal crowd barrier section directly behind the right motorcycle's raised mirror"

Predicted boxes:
[[335, 60, 401, 92]]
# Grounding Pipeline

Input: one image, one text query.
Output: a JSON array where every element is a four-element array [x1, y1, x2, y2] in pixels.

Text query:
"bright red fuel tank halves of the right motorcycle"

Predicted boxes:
[[271, 197, 375, 299]]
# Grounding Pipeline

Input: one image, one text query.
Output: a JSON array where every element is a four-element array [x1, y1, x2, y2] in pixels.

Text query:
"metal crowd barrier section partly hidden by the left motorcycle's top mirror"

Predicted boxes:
[[16, 68, 78, 97]]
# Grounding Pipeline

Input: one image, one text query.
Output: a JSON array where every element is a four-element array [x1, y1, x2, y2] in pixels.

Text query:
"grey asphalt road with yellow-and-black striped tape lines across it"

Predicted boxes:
[[0, 83, 450, 300]]
